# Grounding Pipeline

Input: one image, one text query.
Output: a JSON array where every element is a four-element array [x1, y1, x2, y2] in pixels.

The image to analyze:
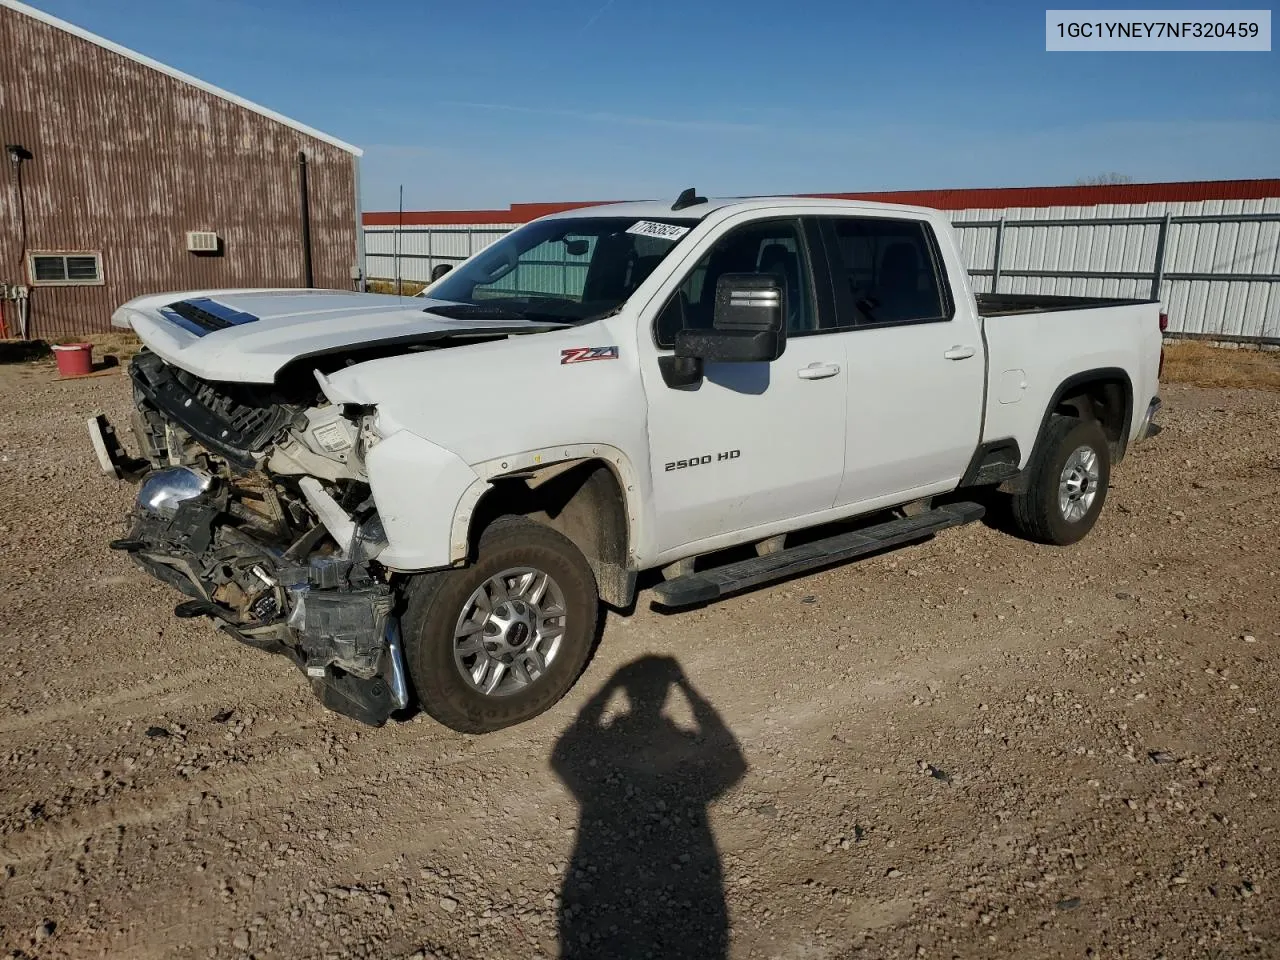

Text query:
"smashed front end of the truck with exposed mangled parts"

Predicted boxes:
[[97, 351, 408, 726]]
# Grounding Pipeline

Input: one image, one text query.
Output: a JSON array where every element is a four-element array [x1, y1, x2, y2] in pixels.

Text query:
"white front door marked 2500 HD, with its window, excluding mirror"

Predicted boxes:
[[641, 218, 847, 553]]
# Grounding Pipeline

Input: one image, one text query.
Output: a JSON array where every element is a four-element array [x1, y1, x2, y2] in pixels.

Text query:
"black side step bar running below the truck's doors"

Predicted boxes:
[[654, 502, 986, 607]]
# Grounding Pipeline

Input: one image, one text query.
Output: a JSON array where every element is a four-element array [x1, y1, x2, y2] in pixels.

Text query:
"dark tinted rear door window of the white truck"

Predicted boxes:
[[827, 216, 951, 326]]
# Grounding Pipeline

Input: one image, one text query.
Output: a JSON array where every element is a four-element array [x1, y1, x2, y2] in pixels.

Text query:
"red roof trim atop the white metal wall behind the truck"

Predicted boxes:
[[365, 179, 1280, 227]]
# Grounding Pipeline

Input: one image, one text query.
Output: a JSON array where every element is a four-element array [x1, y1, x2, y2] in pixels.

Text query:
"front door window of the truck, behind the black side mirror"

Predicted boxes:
[[654, 220, 818, 349]]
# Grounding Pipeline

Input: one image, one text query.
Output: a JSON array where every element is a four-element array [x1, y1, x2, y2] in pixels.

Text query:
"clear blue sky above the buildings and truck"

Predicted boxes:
[[20, 0, 1280, 210]]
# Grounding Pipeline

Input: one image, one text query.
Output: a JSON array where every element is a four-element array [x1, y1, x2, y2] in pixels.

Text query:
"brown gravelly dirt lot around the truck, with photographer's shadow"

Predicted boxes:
[[0, 362, 1280, 960]]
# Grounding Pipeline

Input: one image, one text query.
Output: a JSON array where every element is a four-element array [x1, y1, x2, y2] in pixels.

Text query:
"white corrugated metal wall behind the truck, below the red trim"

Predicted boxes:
[[365, 207, 1280, 346]]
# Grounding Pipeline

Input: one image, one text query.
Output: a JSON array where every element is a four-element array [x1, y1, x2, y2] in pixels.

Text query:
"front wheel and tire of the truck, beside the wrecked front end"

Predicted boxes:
[[403, 517, 599, 733]]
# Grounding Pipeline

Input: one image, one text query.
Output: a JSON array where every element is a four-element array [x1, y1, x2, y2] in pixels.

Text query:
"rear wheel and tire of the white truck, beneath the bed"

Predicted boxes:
[[1012, 415, 1111, 547]]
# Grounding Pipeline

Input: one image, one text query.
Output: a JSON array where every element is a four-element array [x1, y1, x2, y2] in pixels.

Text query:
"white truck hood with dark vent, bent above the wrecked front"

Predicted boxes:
[[111, 289, 559, 383]]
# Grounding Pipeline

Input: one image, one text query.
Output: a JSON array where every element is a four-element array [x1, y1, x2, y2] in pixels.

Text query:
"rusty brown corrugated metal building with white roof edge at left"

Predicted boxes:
[[0, 0, 364, 337]]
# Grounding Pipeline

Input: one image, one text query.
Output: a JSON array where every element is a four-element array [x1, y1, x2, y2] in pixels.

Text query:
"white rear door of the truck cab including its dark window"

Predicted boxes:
[[820, 216, 984, 508]]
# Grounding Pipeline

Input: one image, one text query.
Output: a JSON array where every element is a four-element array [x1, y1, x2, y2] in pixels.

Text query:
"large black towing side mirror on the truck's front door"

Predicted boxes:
[[676, 274, 787, 364]]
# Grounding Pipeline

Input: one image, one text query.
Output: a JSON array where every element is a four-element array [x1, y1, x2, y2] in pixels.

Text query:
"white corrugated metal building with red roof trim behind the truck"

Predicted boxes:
[[365, 179, 1280, 346]]
